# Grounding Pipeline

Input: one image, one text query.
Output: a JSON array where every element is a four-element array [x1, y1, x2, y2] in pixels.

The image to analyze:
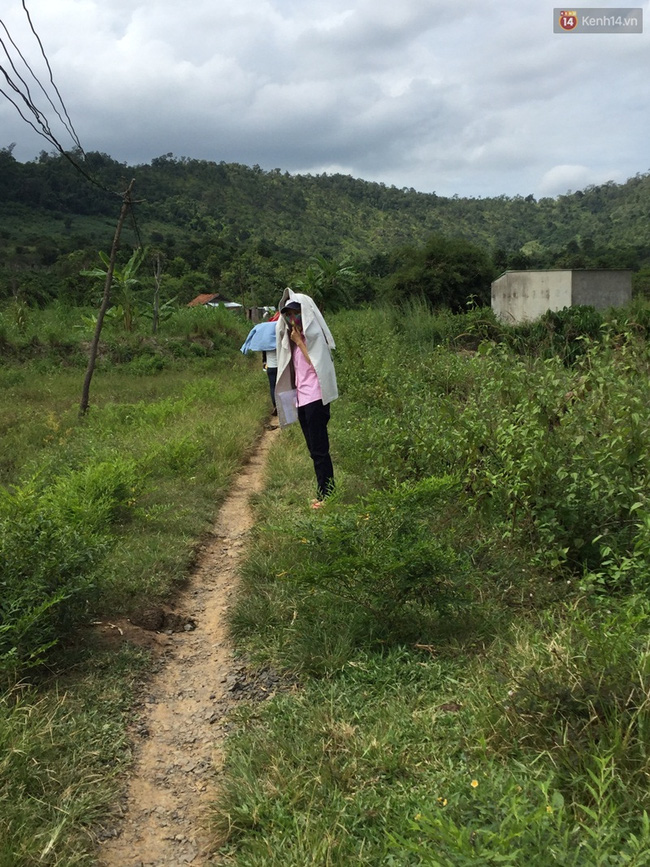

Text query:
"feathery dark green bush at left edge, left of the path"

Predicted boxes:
[[0, 459, 140, 676]]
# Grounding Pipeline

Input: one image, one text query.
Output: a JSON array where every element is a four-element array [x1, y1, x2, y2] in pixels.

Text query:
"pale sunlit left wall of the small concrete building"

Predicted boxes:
[[492, 270, 571, 325]]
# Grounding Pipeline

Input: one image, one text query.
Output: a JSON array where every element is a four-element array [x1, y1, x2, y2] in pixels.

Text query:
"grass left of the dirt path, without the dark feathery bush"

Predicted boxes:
[[0, 313, 270, 867]]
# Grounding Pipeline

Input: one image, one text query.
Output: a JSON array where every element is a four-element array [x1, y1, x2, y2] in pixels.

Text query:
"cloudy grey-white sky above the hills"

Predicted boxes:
[[0, 0, 650, 197]]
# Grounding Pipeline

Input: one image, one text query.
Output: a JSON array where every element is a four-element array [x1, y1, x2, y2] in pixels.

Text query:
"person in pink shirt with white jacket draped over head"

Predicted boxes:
[[275, 289, 338, 509]]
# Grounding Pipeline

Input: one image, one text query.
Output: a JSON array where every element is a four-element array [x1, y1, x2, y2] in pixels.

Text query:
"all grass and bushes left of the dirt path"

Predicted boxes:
[[0, 311, 270, 867]]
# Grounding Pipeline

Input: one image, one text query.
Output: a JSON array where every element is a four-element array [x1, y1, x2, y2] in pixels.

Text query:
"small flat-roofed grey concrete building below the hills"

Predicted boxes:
[[492, 269, 632, 325]]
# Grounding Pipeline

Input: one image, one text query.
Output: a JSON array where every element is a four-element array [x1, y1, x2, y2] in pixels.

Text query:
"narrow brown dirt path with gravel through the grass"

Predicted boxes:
[[97, 430, 278, 867]]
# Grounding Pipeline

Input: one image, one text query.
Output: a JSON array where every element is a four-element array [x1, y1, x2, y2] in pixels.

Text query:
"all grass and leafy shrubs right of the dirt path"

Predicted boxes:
[[215, 309, 650, 867]]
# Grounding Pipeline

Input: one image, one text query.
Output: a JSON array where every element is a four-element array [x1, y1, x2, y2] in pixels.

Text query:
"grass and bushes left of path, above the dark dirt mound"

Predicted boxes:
[[0, 356, 266, 680]]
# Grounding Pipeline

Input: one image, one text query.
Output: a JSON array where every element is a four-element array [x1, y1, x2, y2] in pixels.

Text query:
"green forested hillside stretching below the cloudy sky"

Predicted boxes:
[[0, 146, 650, 304]]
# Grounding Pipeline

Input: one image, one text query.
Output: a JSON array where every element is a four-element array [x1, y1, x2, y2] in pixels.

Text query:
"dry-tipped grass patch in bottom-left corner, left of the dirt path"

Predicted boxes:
[[0, 646, 149, 867]]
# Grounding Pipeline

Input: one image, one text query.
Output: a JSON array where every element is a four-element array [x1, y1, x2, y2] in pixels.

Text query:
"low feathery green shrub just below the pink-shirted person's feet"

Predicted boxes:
[[276, 478, 467, 641]]
